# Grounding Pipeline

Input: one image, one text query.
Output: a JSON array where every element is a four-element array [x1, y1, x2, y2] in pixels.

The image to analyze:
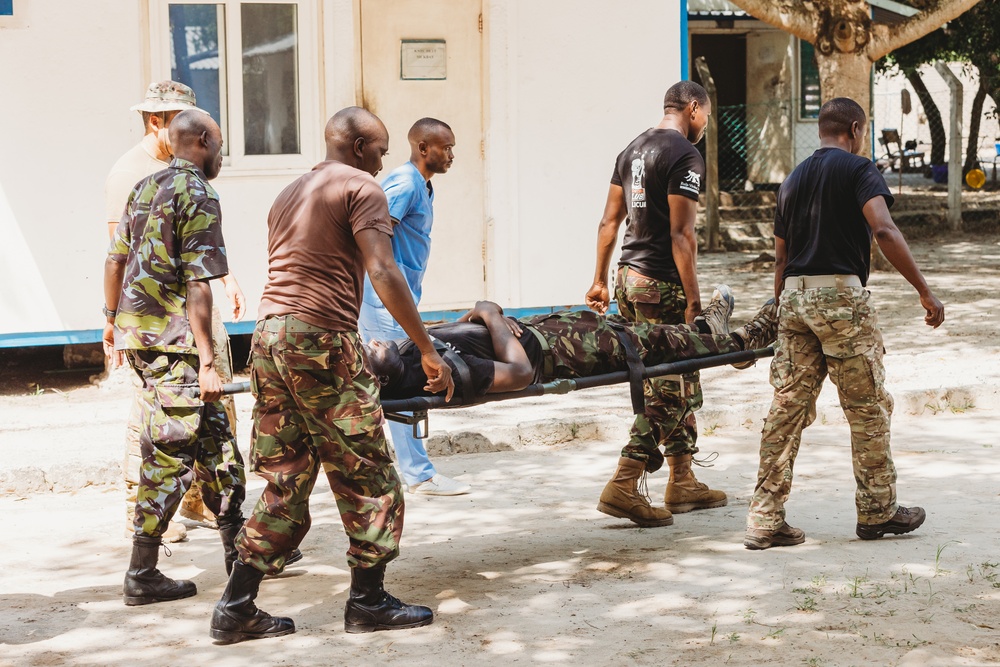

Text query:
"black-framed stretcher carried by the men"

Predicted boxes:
[[223, 347, 774, 439]]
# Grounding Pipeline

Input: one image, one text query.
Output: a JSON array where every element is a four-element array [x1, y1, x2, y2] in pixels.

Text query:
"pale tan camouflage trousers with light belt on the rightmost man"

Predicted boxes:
[[747, 287, 896, 530]]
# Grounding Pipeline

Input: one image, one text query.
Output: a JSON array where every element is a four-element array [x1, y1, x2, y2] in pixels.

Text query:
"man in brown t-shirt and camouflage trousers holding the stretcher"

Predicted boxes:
[[211, 107, 454, 643]]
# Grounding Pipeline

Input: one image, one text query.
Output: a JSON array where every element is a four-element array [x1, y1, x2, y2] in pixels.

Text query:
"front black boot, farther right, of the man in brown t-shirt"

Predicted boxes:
[[344, 565, 434, 633]]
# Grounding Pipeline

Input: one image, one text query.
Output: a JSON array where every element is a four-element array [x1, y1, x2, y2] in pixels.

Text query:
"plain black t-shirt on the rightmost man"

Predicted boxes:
[[774, 148, 893, 285]]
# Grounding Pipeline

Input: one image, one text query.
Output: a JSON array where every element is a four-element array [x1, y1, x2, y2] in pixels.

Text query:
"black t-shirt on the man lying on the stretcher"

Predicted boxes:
[[380, 322, 542, 399]]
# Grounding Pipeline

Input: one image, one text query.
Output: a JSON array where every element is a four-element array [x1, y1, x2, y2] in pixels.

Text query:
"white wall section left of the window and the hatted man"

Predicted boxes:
[[0, 0, 145, 340]]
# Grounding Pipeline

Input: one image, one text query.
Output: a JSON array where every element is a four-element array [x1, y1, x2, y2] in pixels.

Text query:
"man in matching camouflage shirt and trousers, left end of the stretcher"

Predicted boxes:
[[104, 109, 245, 605]]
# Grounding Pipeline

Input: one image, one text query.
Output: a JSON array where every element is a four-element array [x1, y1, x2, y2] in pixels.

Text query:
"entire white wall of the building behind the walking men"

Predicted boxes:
[[0, 0, 681, 338]]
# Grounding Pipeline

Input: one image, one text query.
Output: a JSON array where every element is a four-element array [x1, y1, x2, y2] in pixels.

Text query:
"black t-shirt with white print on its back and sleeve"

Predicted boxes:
[[611, 128, 705, 283]]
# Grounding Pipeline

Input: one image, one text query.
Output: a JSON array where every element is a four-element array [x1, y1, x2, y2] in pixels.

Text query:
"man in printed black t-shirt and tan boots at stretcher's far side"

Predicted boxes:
[[586, 81, 727, 526]]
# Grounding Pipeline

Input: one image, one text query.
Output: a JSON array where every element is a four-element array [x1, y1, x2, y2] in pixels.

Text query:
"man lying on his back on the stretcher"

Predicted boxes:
[[366, 285, 778, 402]]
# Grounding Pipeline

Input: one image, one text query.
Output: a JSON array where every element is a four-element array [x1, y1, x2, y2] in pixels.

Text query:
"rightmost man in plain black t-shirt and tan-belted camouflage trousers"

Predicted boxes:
[[743, 97, 944, 549]]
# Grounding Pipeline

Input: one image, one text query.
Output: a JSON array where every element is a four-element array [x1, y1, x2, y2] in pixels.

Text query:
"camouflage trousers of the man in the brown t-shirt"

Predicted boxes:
[[236, 316, 403, 574]]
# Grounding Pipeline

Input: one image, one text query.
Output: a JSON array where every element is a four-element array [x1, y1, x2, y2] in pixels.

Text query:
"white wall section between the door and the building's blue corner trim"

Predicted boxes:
[[487, 0, 681, 307]]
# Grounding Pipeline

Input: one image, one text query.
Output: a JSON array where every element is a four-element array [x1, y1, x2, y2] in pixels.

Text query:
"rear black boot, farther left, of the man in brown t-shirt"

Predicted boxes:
[[211, 561, 295, 644]]
